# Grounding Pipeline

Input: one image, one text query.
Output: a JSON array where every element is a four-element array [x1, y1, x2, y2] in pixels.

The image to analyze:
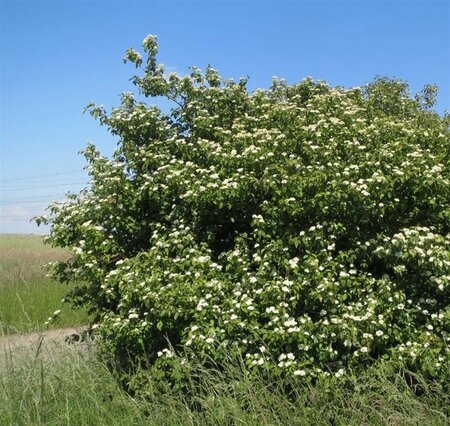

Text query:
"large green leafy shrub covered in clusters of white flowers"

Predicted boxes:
[[37, 36, 450, 384]]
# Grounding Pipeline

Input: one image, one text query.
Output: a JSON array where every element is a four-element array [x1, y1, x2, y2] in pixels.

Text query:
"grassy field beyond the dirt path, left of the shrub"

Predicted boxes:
[[0, 235, 87, 335]]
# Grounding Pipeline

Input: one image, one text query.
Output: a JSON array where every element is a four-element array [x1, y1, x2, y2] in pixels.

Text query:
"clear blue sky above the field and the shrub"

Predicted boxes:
[[0, 0, 450, 233]]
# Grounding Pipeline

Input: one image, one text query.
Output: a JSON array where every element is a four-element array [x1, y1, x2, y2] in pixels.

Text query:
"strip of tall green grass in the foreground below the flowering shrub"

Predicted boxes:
[[0, 345, 450, 426]]
